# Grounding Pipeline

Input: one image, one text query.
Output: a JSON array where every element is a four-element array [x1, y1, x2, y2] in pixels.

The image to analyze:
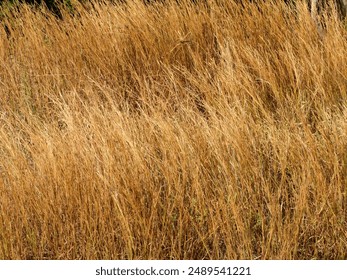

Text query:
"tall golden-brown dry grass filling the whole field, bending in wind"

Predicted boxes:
[[0, 1, 347, 259]]
